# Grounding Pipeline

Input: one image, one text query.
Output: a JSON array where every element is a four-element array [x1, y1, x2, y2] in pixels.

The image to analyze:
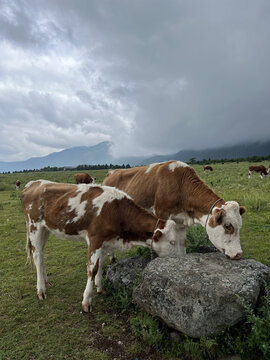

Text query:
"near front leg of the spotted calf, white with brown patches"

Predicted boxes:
[[82, 248, 102, 312]]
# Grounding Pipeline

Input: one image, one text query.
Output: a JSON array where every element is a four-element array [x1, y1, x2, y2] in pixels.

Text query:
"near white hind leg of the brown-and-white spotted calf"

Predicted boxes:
[[28, 224, 49, 299]]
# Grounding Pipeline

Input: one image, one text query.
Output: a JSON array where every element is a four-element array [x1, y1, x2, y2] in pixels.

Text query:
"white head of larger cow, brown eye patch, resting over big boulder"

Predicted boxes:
[[206, 201, 245, 259]]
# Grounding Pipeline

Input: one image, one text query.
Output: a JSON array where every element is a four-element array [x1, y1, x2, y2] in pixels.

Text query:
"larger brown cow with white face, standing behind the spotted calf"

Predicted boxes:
[[103, 161, 245, 259]]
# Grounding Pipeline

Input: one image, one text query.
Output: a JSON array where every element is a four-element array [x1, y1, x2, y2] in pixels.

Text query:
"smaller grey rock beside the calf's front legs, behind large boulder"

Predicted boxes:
[[106, 256, 151, 288]]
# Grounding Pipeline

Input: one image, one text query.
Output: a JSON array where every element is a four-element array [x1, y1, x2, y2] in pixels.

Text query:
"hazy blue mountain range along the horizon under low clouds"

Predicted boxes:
[[0, 141, 270, 172]]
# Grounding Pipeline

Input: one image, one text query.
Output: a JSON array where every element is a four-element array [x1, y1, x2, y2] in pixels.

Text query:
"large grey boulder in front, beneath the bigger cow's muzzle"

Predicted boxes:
[[133, 253, 270, 338]]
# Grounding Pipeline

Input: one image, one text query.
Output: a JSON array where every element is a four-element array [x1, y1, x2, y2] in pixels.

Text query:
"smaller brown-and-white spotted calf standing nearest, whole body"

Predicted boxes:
[[21, 180, 181, 312]]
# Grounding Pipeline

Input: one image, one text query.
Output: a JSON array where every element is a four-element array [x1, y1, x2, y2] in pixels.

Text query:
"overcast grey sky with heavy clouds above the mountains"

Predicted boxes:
[[0, 0, 270, 161]]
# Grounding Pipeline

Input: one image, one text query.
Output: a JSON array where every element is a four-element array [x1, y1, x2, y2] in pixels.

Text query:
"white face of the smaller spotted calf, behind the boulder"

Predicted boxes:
[[152, 220, 186, 256]]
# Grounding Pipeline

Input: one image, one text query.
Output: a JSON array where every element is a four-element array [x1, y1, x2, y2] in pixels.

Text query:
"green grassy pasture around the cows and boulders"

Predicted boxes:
[[0, 162, 270, 360]]
